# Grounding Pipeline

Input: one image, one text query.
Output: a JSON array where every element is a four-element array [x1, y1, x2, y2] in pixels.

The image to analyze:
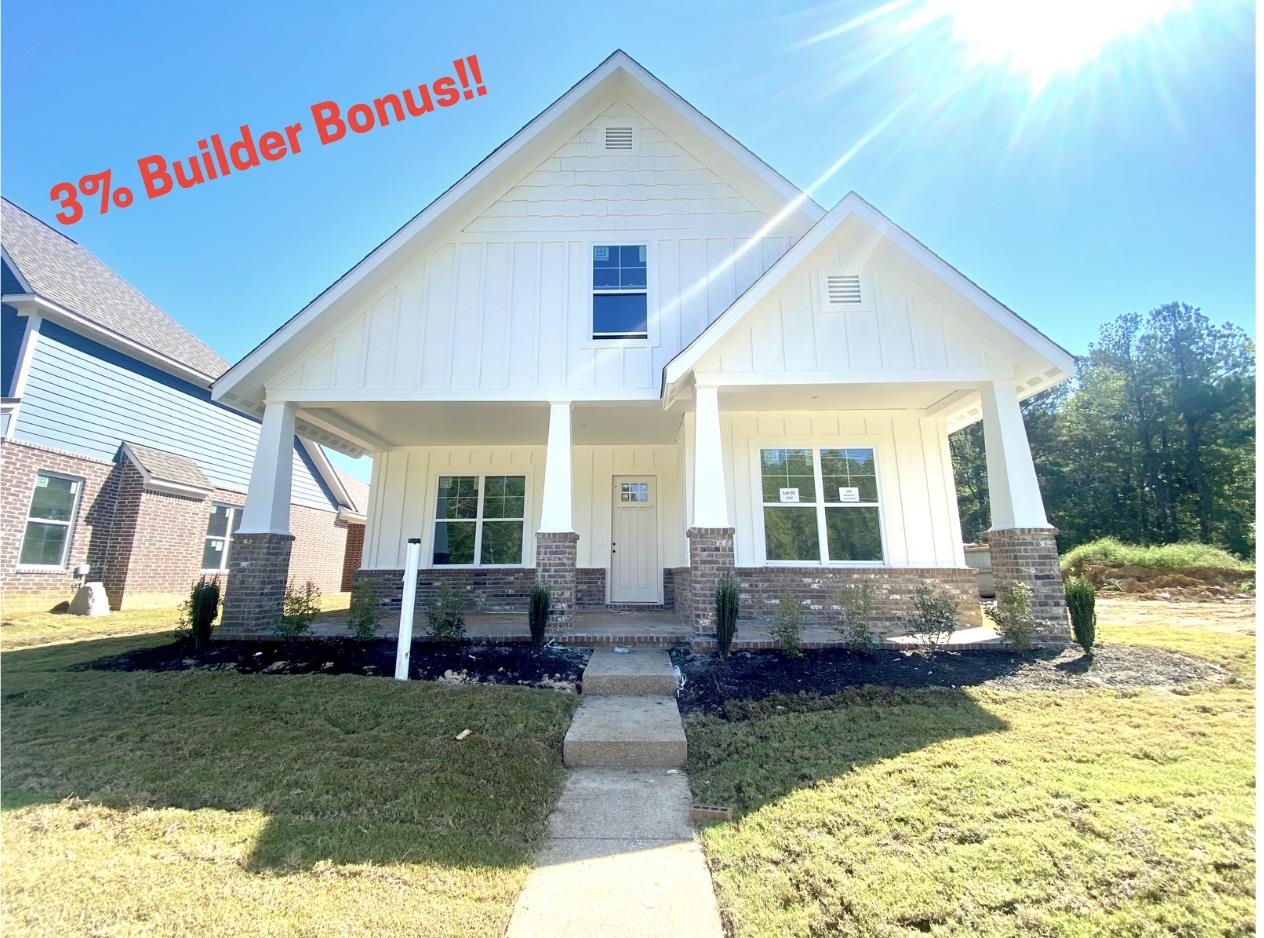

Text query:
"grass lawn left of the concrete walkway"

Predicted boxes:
[[0, 613, 576, 935]]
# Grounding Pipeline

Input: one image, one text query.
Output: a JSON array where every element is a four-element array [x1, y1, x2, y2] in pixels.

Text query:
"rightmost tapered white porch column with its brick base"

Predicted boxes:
[[980, 381, 1068, 642]]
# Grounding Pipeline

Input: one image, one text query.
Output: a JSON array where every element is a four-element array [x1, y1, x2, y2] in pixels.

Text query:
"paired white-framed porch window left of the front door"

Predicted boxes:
[[432, 475, 527, 566]]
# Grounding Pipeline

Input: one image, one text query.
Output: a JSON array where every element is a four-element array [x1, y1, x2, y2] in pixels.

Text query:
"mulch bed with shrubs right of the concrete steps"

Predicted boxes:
[[671, 645, 1225, 713]]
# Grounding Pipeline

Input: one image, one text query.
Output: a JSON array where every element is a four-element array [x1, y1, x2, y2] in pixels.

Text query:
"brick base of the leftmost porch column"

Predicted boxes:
[[214, 533, 295, 638]]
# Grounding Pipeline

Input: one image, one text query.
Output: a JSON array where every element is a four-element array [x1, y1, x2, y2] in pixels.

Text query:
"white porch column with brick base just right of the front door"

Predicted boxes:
[[685, 384, 734, 636]]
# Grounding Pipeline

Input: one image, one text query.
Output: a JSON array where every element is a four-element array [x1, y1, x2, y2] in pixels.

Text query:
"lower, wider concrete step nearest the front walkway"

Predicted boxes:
[[562, 694, 689, 769]]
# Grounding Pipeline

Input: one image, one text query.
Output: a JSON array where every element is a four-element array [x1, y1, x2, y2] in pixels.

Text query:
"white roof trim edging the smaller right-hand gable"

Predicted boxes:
[[662, 192, 1076, 393]]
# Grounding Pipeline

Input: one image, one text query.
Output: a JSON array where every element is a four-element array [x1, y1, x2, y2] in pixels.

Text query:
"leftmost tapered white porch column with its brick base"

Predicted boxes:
[[215, 402, 295, 638]]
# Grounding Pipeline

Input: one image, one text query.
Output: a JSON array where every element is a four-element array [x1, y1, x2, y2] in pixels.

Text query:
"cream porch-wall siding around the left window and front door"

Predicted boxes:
[[363, 446, 685, 570]]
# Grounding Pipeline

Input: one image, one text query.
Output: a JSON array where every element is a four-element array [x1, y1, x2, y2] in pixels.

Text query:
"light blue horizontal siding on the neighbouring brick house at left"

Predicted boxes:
[[14, 321, 334, 509]]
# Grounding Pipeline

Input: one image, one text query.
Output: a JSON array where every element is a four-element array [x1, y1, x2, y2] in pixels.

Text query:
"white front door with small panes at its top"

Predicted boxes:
[[611, 475, 662, 603]]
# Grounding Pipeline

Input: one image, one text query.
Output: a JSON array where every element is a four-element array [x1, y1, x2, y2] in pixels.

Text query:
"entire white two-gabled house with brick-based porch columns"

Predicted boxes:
[[212, 52, 1074, 635]]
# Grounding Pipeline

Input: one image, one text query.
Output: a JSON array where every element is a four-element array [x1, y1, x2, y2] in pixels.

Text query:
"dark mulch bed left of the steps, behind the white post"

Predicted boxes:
[[78, 640, 592, 693]]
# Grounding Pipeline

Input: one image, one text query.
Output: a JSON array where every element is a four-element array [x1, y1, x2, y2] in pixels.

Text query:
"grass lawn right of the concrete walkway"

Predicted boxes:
[[686, 602, 1255, 937]]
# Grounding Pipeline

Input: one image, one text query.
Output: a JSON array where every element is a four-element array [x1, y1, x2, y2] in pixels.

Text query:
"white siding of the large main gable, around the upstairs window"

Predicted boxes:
[[268, 105, 803, 399]]
